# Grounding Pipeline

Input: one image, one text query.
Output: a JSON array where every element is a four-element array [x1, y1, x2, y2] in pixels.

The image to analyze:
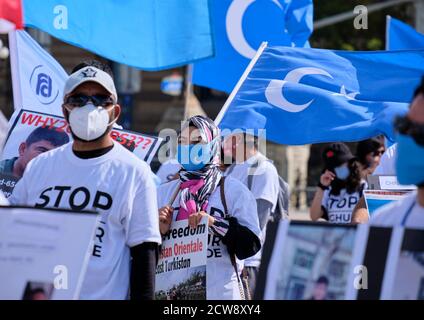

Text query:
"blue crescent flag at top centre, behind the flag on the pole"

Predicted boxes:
[[193, 0, 313, 92]]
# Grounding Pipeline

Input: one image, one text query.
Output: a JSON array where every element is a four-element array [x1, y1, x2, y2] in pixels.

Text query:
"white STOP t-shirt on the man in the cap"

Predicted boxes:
[[9, 142, 161, 300]]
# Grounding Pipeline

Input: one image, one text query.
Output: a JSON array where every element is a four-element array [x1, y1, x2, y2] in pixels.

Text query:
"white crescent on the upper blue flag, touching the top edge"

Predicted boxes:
[[225, 0, 283, 60]]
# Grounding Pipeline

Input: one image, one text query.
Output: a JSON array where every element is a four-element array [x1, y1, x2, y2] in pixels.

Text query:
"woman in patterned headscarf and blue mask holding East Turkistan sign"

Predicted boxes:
[[157, 116, 261, 300]]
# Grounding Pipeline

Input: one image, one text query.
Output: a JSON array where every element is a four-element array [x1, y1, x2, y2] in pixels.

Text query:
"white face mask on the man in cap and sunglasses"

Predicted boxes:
[[68, 103, 116, 141]]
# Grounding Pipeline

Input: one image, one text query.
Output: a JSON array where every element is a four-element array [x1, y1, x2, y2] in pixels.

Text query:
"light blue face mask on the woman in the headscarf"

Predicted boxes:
[[177, 140, 214, 171]]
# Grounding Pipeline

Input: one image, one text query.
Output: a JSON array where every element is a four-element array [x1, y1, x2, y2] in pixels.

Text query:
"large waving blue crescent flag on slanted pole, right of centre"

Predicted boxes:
[[218, 47, 424, 145]]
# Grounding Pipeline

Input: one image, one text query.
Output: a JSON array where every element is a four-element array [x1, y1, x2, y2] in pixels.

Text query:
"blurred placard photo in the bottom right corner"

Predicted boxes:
[[381, 227, 424, 300]]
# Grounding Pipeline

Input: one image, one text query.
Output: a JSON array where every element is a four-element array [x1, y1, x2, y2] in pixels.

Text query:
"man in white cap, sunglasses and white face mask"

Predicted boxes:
[[10, 61, 161, 300]]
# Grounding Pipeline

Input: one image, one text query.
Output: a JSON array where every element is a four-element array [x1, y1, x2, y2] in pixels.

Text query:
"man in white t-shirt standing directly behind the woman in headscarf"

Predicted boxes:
[[223, 133, 280, 295]]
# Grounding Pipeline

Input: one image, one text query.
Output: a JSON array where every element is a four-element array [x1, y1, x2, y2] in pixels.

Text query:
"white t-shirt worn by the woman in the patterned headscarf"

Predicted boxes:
[[157, 177, 261, 300]]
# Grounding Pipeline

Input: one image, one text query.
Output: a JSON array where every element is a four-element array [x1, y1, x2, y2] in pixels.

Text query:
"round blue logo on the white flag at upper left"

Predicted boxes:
[[29, 65, 59, 105]]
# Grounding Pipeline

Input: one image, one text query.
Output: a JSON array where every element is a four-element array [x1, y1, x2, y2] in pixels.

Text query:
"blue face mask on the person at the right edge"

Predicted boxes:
[[396, 134, 424, 185]]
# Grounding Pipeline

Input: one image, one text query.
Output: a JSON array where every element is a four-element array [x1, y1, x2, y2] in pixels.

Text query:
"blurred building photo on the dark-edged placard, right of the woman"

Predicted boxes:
[[264, 221, 364, 300]]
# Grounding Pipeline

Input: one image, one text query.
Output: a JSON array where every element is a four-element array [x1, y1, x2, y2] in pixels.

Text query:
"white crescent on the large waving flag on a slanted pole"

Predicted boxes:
[[265, 67, 333, 112]]
